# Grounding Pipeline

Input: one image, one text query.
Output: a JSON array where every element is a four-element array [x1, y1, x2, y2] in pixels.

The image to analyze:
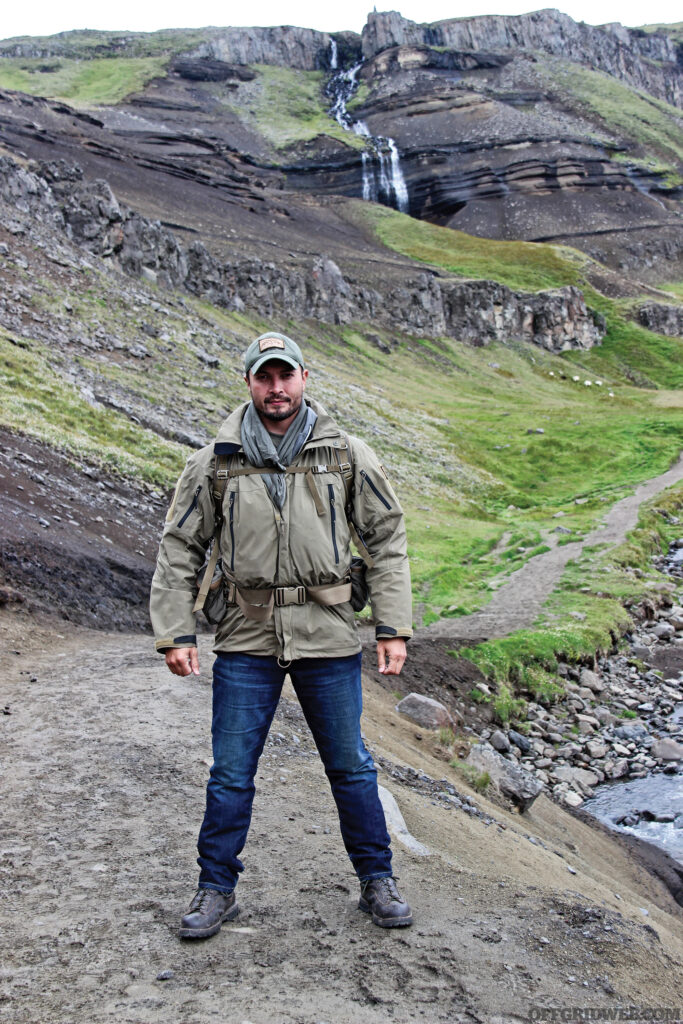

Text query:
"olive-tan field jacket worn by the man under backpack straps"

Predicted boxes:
[[150, 398, 413, 660]]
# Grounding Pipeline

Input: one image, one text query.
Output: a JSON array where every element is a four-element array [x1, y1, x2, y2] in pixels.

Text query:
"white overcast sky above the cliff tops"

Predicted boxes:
[[0, 0, 682, 39]]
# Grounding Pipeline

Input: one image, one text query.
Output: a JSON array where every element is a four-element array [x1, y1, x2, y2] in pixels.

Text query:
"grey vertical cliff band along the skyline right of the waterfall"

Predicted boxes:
[[362, 9, 683, 106]]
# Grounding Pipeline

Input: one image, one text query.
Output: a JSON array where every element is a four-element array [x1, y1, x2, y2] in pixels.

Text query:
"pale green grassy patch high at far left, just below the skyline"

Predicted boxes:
[[0, 57, 168, 106]]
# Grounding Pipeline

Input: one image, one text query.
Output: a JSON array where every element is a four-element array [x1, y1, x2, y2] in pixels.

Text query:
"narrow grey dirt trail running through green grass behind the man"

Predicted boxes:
[[428, 455, 683, 640]]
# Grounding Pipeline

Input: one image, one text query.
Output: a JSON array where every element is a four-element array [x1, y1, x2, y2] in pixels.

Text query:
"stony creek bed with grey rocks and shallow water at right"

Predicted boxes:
[[466, 539, 683, 865]]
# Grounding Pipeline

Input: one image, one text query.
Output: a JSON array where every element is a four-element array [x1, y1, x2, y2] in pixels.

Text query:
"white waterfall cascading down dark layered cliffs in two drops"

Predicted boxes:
[[325, 50, 410, 213]]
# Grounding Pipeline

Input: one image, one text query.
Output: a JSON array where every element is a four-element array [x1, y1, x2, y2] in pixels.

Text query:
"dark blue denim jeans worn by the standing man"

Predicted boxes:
[[198, 653, 391, 891]]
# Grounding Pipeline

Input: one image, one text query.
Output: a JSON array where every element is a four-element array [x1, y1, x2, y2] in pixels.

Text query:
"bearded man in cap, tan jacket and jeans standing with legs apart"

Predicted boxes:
[[151, 333, 412, 938]]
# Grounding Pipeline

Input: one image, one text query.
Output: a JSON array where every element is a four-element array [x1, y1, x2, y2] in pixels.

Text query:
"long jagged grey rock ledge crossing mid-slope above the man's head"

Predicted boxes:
[[0, 158, 604, 352]]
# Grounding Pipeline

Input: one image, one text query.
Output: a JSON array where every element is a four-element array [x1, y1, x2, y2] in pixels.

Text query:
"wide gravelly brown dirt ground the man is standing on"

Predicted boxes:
[[0, 612, 683, 1024]]
